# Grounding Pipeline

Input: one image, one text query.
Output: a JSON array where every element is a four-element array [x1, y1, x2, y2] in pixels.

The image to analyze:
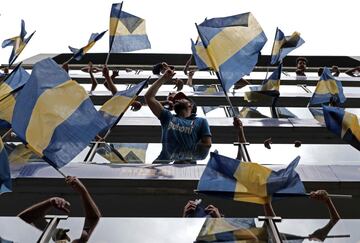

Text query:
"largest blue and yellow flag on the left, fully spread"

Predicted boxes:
[[12, 58, 106, 168]]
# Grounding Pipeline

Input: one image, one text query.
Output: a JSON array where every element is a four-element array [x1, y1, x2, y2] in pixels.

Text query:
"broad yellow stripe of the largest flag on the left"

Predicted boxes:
[[26, 80, 88, 154]]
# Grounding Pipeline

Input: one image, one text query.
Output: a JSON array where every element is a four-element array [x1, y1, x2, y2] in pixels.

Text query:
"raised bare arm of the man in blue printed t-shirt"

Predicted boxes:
[[145, 69, 175, 118]]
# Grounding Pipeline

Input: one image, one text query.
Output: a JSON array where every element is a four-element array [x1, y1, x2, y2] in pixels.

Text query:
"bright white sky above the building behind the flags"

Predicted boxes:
[[0, 0, 360, 64]]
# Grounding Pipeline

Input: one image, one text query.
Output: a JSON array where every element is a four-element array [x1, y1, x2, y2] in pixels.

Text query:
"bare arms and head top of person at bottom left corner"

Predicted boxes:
[[18, 176, 101, 243]]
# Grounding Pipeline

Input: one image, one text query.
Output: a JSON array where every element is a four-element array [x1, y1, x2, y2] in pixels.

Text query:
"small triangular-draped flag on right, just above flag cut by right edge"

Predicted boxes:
[[309, 67, 346, 105]]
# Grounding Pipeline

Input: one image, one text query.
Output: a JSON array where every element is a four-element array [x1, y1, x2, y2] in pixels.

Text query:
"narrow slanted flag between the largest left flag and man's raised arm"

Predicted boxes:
[[99, 79, 148, 129]]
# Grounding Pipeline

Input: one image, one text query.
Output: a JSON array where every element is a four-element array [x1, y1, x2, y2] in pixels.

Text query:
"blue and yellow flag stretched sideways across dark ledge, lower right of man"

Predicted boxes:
[[197, 153, 305, 204]]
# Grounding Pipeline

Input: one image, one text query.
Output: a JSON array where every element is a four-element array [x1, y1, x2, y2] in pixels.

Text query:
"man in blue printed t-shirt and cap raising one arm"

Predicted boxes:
[[145, 68, 211, 160]]
